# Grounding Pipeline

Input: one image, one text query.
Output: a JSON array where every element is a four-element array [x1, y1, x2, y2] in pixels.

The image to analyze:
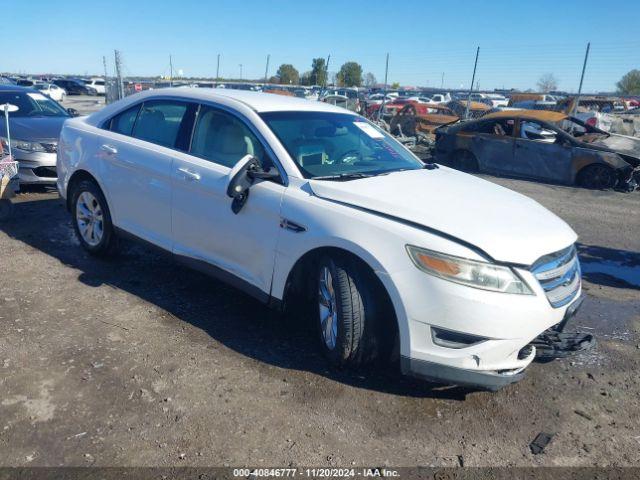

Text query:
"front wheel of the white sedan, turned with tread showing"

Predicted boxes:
[[313, 255, 384, 367]]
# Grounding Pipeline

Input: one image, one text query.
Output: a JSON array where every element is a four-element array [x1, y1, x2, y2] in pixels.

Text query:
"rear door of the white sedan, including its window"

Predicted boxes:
[[97, 100, 196, 250]]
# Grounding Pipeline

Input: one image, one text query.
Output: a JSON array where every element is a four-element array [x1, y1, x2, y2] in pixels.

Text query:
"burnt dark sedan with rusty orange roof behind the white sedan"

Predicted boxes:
[[435, 110, 640, 191]]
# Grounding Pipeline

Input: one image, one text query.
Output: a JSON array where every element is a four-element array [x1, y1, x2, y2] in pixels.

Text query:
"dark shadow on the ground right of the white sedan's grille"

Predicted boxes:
[[577, 243, 640, 290]]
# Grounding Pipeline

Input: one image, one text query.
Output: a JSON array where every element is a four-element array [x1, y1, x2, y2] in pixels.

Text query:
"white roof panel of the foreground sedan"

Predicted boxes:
[[131, 88, 353, 114]]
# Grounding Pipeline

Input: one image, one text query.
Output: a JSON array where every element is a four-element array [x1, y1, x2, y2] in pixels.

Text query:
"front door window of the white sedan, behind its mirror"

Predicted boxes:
[[190, 105, 270, 168]]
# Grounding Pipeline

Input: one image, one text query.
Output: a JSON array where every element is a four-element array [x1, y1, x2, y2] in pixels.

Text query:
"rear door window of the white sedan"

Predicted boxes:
[[133, 100, 187, 148]]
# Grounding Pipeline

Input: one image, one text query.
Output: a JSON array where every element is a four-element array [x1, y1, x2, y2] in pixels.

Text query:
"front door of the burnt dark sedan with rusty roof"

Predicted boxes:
[[513, 120, 573, 183]]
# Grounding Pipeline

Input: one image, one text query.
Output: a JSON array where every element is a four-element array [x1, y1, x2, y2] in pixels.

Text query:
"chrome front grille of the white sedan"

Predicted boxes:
[[531, 245, 581, 308]]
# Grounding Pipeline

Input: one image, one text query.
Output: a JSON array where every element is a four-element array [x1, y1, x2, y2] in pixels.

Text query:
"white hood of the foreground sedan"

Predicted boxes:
[[309, 167, 577, 265]]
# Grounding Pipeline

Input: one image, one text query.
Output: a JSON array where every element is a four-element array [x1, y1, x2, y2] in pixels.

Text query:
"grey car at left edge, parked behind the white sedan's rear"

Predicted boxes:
[[0, 85, 76, 185]]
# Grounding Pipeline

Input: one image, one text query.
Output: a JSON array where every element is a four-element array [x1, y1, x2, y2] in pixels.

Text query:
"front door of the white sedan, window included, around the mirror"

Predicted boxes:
[[171, 105, 285, 294]]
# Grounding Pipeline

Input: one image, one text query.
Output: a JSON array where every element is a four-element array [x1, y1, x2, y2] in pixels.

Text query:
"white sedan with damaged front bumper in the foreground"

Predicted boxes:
[[58, 89, 581, 389]]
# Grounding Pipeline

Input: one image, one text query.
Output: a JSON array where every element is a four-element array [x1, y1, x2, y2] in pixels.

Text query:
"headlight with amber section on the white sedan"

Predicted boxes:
[[407, 245, 533, 295]]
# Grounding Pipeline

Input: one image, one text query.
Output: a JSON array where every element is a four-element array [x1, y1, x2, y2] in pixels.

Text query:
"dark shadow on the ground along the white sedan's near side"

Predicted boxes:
[[0, 195, 475, 400]]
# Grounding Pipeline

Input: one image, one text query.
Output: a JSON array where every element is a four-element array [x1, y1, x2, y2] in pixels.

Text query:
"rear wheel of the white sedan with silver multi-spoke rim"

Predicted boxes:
[[71, 180, 116, 256]]
